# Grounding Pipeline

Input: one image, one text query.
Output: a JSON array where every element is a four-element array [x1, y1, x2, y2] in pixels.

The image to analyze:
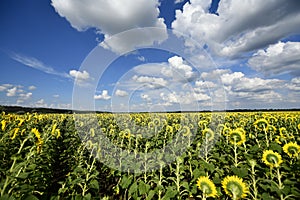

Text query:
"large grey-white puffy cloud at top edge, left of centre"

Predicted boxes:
[[52, 0, 167, 53]]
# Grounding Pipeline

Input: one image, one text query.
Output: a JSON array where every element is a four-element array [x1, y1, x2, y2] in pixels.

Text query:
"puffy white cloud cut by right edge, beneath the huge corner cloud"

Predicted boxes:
[[248, 42, 300, 75]]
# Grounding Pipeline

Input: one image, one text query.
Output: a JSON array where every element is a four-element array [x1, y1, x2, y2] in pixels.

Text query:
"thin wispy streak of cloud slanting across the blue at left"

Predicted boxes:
[[11, 54, 69, 78]]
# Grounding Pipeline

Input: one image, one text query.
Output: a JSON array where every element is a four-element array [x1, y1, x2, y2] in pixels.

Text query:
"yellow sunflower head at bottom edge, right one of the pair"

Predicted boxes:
[[222, 176, 249, 199]]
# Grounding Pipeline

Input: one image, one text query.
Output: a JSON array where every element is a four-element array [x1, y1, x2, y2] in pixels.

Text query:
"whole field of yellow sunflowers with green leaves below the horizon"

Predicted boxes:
[[0, 112, 300, 200]]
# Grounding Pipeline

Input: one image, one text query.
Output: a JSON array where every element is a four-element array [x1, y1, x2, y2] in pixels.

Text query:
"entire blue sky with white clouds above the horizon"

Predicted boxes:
[[0, 0, 300, 111]]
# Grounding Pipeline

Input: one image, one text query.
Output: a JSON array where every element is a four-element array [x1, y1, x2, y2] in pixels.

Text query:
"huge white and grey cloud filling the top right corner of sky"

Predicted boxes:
[[172, 0, 300, 57]]
